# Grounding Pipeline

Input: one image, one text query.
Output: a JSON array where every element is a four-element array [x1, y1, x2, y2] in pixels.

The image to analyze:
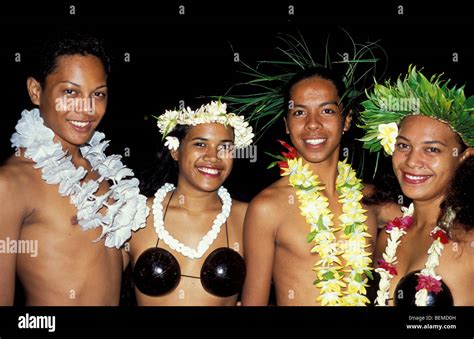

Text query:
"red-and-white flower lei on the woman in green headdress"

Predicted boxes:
[[375, 204, 449, 306]]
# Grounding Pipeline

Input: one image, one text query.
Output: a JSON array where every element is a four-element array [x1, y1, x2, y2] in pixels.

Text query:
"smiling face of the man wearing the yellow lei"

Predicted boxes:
[[286, 77, 350, 163]]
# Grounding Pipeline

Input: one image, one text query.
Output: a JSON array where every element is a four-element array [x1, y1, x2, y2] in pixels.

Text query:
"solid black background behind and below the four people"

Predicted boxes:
[[0, 0, 474, 339]]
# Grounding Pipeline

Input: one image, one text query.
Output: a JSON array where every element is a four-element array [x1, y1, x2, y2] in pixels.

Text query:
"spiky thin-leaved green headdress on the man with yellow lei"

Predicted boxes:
[[219, 30, 386, 140]]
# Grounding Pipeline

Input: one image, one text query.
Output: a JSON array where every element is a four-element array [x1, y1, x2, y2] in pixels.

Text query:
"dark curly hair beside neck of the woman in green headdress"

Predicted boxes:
[[439, 157, 474, 235]]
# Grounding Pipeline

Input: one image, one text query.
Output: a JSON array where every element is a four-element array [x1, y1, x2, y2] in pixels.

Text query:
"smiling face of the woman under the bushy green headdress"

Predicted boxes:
[[392, 115, 461, 201]]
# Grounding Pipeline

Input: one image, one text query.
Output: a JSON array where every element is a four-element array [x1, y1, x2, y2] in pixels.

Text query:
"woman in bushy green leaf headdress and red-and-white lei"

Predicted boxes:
[[361, 67, 474, 306]]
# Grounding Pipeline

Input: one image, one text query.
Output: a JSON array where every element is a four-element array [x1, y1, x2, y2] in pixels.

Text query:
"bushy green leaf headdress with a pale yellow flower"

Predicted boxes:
[[359, 66, 474, 155]]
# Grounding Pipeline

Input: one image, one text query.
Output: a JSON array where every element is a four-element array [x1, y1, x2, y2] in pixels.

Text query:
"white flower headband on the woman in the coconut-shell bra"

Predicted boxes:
[[157, 101, 254, 150]]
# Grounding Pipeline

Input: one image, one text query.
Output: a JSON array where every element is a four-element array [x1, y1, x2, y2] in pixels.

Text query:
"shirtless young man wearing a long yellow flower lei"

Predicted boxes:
[[242, 67, 377, 306]]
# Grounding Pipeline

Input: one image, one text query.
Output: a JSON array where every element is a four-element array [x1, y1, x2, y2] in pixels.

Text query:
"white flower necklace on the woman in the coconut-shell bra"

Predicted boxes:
[[153, 183, 232, 259]]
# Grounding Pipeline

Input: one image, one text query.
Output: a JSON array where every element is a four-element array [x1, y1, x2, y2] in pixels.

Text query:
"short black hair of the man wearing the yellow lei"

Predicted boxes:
[[283, 67, 349, 116]]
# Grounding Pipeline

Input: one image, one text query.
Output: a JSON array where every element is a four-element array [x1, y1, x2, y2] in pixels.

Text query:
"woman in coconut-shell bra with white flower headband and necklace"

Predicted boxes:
[[130, 101, 253, 306]]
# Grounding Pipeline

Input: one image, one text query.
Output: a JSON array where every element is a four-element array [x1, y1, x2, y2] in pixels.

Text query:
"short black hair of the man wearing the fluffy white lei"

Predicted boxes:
[[34, 32, 110, 86]]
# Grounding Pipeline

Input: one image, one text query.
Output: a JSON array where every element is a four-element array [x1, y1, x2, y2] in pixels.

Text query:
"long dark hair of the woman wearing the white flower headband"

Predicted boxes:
[[140, 125, 189, 197]]
